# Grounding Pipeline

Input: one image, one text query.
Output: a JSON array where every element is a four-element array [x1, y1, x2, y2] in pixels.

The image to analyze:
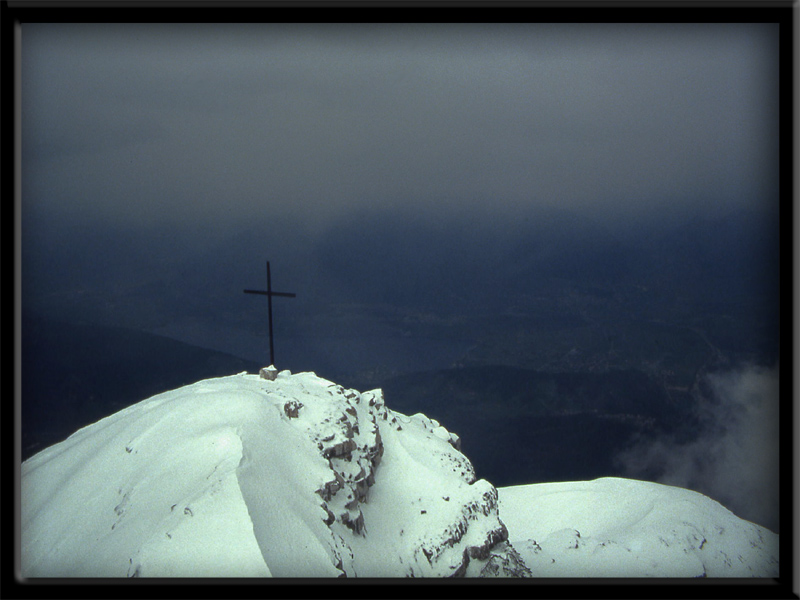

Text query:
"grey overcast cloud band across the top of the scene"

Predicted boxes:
[[22, 23, 778, 235]]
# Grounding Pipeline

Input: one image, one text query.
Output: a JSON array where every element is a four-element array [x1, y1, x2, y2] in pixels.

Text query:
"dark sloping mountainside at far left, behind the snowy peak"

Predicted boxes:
[[21, 314, 264, 459]]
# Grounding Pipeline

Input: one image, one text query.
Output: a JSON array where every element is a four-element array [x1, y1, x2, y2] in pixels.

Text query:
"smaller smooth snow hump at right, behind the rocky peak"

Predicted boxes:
[[499, 477, 778, 577]]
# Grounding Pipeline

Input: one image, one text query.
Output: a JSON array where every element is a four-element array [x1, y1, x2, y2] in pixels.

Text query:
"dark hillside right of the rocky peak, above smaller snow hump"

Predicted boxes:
[[383, 366, 695, 486]]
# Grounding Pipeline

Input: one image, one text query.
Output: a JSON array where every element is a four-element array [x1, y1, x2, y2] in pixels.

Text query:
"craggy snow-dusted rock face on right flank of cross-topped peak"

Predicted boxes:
[[266, 372, 527, 577]]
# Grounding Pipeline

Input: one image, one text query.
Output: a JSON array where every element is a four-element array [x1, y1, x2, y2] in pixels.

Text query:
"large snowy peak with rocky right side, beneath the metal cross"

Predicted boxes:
[[21, 371, 528, 577]]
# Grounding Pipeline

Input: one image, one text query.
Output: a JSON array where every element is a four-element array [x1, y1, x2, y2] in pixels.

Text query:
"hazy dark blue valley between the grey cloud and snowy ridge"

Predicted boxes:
[[22, 206, 779, 528]]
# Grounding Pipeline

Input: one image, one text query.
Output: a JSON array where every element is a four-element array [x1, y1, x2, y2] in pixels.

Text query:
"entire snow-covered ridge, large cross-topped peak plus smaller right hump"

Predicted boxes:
[[21, 371, 778, 578]]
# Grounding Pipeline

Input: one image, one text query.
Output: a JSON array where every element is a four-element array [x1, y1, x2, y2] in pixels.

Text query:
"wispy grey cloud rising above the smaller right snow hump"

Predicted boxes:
[[618, 365, 790, 531]]
